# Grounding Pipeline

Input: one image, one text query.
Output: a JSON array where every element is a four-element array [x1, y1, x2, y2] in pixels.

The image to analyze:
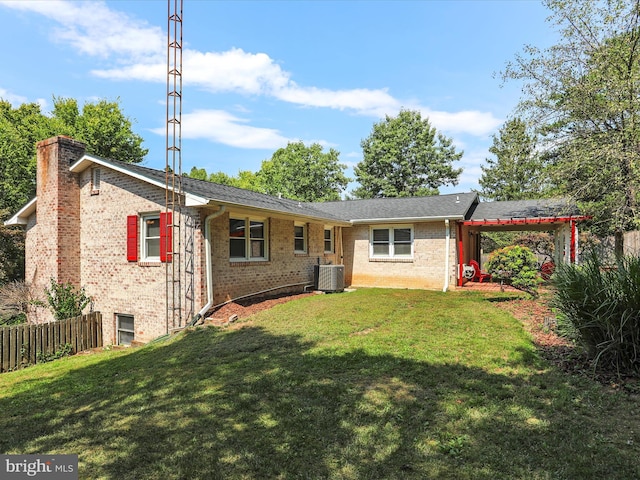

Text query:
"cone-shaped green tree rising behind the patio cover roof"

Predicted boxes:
[[479, 118, 548, 200]]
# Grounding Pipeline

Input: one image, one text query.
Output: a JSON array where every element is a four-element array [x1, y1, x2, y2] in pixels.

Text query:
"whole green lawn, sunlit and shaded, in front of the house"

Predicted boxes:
[[0, 289, 640, 480]]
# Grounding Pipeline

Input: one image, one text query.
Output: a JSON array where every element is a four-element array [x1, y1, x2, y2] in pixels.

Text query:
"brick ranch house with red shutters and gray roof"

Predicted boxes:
[[5, 136, 583, 344]]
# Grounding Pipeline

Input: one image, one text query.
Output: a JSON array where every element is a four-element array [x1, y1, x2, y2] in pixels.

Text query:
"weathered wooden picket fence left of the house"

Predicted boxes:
[[0, 312, 102, 373]]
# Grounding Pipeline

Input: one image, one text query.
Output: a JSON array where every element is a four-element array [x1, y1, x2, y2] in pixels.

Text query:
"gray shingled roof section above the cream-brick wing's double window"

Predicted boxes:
[[314, 193, 478, 223]]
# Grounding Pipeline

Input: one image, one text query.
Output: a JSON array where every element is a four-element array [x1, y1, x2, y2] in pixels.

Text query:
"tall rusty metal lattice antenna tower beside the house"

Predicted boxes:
[[166, 0, 184, 333]]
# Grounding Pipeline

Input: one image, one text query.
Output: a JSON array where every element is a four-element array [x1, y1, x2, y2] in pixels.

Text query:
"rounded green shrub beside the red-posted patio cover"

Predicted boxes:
[[485, 245, 542, 297]]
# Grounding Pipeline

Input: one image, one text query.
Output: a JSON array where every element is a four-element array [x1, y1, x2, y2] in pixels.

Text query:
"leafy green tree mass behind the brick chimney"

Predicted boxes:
[[0, 98, 147, 284]]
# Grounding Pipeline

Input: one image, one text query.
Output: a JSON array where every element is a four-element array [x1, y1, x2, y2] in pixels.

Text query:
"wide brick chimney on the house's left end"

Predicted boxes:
[[32, 136, 85, 287]]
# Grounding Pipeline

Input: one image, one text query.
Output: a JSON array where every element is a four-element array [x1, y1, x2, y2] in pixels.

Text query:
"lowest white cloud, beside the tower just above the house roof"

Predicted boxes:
[[152, 110, 297, 150]]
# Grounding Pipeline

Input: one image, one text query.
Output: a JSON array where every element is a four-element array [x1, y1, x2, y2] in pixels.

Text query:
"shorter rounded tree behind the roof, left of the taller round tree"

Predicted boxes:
[[258, 142, 349, 202]]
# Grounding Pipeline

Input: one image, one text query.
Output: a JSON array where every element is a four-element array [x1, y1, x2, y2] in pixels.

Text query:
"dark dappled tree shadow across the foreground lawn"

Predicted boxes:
[[0, 327, 640, 479]]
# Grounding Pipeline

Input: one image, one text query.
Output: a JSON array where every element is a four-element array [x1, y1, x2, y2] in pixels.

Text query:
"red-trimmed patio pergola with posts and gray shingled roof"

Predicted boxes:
[[457, 199, 590, 286]]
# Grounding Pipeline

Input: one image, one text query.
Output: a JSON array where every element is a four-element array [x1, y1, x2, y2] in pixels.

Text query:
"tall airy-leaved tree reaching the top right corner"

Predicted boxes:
[[504, 0, 640, 252]]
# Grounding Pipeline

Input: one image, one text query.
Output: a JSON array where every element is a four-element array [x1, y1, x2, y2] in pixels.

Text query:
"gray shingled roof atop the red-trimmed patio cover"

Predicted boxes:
[[468, 199, 579, 220]]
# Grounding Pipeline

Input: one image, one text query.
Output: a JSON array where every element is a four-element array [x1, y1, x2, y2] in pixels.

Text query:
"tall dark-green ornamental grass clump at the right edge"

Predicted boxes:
[[552, 253, 640, 374]]
